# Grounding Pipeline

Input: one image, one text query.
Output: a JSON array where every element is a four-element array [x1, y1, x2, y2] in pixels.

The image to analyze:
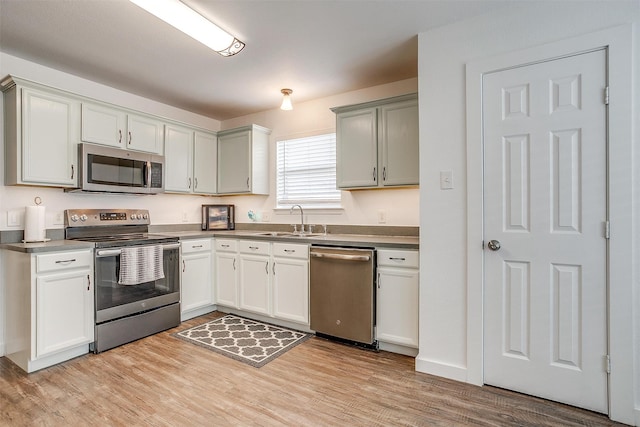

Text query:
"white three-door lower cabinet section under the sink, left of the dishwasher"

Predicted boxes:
[[215, 239, 309, 326]]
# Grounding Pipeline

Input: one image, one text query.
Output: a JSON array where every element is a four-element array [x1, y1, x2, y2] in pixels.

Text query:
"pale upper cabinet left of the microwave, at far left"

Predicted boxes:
[[1, 78, 80, 188]]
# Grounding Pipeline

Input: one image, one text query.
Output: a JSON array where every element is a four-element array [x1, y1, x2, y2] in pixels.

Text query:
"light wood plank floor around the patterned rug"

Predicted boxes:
[[0, 313, 621, 426]]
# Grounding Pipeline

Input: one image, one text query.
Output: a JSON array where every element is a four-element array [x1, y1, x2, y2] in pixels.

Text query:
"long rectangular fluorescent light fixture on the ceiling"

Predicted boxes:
[[129, 0, 244, 56]]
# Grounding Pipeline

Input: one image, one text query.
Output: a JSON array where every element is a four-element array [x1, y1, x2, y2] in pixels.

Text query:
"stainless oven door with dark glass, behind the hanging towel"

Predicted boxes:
[[95, 243, 180, 324]]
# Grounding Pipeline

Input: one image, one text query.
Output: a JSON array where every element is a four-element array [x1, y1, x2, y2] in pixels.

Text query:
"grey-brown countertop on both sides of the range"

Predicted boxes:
[[0, 230, 419, 253]]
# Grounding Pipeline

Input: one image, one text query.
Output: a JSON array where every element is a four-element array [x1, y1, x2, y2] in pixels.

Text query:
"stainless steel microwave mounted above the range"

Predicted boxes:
[[73, 144, 164, 194]]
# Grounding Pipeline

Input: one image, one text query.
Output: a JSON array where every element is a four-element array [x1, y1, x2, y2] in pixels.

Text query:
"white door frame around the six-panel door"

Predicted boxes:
[[466, 25, 634, 424]]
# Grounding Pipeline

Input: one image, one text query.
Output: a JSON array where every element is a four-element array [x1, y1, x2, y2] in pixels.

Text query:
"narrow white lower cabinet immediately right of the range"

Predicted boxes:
[[180, 239, 214, 320]]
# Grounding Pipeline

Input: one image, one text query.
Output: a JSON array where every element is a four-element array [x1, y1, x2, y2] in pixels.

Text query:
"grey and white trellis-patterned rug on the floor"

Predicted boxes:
[[173, 314, 311, 368]]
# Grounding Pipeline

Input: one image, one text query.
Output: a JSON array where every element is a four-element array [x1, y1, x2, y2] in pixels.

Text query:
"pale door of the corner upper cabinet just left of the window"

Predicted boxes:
[[218, 131, 251, 194]]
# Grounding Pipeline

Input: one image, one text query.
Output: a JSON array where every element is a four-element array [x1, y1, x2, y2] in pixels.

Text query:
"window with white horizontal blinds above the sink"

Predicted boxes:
[[276, 133, 340, 208]]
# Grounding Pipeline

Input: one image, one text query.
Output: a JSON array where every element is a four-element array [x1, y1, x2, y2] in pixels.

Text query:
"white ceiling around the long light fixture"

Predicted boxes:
[[0, 0, 509, 120]]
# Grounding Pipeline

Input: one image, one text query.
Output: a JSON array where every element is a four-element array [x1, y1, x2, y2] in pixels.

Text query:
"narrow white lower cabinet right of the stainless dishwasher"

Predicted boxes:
[[376, 249, 419, 355]]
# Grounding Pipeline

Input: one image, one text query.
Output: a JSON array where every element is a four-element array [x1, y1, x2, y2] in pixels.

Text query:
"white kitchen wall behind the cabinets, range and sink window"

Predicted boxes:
[[0, 52, 419, 356]]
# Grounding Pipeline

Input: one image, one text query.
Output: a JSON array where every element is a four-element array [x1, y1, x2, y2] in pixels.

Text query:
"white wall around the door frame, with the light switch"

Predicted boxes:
[[416, 1, 640, 425]]
